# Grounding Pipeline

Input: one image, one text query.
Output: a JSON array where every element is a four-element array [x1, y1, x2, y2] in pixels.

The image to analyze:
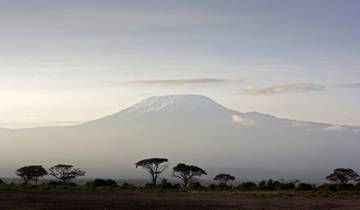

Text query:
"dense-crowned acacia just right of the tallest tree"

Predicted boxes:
[[173, 163, 207, 188]]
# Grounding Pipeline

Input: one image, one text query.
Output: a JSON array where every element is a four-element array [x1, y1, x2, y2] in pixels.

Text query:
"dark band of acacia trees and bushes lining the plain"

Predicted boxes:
[[0, 158, 360, 195]]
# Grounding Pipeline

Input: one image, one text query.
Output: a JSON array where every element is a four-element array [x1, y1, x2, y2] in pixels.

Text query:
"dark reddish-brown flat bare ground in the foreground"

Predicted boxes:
[[0, 191, 360, 210]]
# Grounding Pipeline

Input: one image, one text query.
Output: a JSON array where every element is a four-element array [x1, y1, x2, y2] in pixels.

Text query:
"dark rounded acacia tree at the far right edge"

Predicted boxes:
[[326, 168, 360, 184]]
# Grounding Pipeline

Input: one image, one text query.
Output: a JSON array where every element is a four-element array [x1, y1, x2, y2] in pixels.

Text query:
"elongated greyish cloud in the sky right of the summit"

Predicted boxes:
[[244, 83, 326, 95]]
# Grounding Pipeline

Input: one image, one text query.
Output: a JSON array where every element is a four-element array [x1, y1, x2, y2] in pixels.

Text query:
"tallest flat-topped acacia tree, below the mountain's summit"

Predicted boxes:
[[135, 158, 168, 186]]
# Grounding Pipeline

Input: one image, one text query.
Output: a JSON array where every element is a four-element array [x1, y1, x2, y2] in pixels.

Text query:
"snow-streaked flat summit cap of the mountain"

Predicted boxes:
[[125, 95, 225, 113]]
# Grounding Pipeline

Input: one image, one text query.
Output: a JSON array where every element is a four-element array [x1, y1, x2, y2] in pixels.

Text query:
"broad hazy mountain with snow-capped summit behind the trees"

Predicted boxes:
[[0, 95, 360, 181]]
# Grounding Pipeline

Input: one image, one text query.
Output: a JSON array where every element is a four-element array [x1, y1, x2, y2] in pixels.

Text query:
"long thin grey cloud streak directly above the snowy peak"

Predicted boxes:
[[120, 78, 241, 85]]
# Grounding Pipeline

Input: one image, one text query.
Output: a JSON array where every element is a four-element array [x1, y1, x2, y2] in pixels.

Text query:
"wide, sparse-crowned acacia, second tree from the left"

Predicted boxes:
[[49, 164, 85, 183]]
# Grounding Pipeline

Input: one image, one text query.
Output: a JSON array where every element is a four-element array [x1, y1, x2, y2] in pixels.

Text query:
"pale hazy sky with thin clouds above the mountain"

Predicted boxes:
[[0, 0, 360, 128]]
